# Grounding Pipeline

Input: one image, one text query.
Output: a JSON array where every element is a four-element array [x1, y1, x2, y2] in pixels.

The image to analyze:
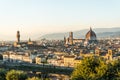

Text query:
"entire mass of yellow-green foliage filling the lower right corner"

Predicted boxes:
[[71, 57, 120, 80]]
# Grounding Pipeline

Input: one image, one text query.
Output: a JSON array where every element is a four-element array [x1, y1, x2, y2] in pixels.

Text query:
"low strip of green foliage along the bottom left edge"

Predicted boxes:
[[0, 69, 50, 80]]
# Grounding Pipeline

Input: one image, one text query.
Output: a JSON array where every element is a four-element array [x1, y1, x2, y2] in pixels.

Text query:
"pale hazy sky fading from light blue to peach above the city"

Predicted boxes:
[[0, 0, 120, 40]]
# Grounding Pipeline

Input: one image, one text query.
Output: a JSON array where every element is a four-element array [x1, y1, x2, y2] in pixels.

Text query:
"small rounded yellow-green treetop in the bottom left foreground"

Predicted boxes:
[[6, 70, 27, 80]]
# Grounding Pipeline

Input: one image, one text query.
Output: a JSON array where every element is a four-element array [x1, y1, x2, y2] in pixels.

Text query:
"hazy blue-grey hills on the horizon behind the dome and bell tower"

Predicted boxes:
[[38, 27, 120, 40]]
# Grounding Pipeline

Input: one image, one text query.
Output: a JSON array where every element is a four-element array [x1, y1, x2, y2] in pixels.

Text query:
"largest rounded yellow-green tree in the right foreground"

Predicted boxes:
[[71, 56, 107, 80]]
